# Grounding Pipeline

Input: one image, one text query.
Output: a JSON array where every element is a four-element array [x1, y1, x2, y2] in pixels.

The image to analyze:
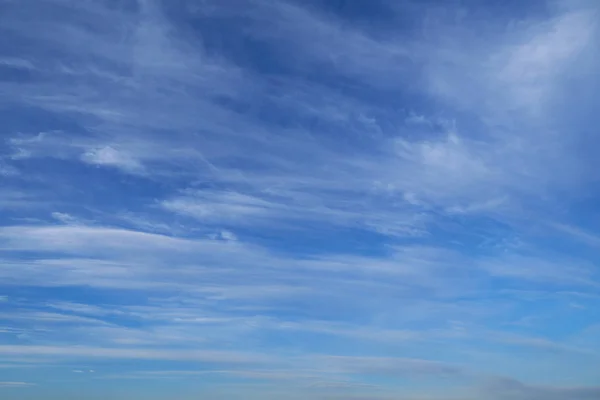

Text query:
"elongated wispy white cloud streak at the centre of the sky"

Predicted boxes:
[[162, 187, 425, 236]]
